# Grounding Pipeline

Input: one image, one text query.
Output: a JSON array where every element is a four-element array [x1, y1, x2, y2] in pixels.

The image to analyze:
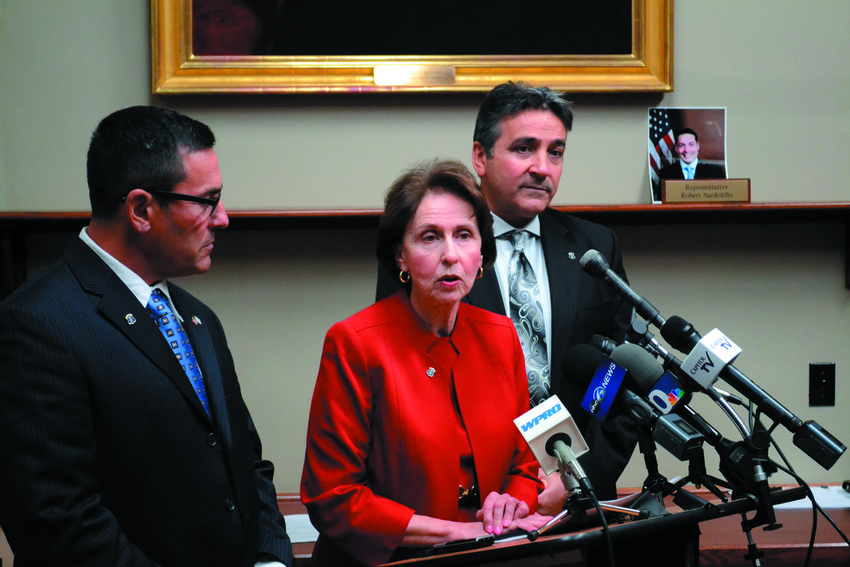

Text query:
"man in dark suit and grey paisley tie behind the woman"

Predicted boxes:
[[377, 83, 637, 514]]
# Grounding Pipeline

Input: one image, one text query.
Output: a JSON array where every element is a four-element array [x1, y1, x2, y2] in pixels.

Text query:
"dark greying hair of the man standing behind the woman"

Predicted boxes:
[[472, 81, 573, 157]]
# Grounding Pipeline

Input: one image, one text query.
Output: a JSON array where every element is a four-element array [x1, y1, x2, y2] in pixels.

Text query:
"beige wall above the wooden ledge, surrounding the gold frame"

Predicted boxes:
[[0, 0, 850, 210]]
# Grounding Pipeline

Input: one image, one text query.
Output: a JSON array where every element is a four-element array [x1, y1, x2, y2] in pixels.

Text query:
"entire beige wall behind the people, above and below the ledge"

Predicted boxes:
[[0, 0, 850, 560]]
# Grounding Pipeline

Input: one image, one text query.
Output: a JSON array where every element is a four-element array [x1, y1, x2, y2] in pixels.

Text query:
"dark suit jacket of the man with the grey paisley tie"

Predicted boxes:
[[378, 209, 637, 499]]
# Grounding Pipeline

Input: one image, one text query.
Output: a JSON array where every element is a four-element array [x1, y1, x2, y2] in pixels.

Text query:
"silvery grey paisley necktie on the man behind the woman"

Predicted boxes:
[[504, 230, 551, 407]]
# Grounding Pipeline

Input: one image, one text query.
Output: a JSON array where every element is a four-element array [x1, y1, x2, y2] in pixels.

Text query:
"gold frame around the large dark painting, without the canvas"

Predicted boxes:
[[151, 0, 673, 94]]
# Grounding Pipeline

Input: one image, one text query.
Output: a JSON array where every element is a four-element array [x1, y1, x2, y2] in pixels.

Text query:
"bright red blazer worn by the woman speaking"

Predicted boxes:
[[301, 292, 541, 565]]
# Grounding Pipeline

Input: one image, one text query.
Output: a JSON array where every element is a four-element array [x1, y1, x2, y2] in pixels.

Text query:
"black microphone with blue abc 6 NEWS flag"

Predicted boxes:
[[563, 345, 704, 460]]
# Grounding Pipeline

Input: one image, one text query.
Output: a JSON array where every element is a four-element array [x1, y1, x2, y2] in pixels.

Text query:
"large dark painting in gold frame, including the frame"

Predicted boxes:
[[151, 0, 673, 94]]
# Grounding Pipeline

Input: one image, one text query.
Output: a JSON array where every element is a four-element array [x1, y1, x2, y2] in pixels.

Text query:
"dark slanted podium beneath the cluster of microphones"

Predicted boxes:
[[386, 487, 805, 567]]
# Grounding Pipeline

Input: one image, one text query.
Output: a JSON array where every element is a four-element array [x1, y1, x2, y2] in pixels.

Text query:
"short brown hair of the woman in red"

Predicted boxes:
[[375, 160, 496, 287]]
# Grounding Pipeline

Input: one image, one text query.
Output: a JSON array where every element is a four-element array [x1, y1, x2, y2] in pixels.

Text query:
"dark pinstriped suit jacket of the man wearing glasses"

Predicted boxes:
[[0, 240, 292, 567]]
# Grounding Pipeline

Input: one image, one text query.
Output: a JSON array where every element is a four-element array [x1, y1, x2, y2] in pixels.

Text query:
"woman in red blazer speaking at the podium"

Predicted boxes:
[[301, 162, 546, 565]]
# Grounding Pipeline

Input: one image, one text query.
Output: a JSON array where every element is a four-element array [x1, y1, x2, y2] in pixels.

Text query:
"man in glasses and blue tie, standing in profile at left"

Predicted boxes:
[[0, 107, 292, 567]]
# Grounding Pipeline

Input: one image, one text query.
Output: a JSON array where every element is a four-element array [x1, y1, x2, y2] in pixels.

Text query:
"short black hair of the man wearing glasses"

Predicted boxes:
[[86, 106, 215, 218]]
